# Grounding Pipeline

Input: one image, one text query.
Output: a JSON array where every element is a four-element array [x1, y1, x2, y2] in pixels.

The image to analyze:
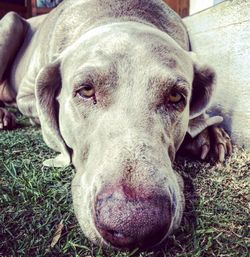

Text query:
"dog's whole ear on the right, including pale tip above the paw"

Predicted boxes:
[[188, 52, 223, 137]]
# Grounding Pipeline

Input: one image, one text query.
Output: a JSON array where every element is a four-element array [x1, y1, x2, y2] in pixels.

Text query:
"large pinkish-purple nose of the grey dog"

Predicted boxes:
[[95, 186, 171, 249]]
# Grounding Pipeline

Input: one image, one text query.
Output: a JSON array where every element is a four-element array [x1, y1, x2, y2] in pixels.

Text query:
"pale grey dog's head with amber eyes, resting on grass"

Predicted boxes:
[[36, 22, 213, 248]]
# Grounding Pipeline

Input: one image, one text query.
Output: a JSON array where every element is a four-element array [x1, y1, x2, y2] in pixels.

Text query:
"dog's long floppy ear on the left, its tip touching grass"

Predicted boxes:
[[35, 61, 71, 167]]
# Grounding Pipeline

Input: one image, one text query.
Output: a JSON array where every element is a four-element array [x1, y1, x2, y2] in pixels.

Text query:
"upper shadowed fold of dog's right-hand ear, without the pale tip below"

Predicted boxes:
[[190, 53, 216, 119]]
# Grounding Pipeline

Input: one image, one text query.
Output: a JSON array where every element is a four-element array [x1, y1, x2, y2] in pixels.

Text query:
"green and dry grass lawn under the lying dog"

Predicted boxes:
[[0, 109, 250, 257]]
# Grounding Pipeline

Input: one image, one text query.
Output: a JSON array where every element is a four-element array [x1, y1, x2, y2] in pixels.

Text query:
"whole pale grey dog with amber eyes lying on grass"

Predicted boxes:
[[0, 0, 232, 249]]
